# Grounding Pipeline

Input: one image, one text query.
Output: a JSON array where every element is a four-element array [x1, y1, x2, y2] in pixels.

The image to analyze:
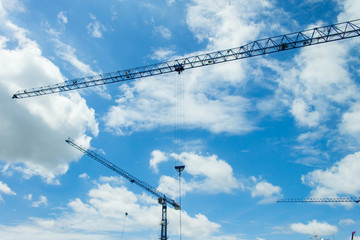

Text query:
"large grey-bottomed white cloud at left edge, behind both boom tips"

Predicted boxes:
[[0, 7, 99, 184]]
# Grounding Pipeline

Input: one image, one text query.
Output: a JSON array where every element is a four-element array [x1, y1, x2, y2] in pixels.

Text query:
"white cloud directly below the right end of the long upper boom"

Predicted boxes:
[[268, 42, 358, 131]]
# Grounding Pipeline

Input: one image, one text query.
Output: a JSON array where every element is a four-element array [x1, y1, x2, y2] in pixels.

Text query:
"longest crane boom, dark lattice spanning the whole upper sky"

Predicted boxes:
[[12, 19, 360, 99]]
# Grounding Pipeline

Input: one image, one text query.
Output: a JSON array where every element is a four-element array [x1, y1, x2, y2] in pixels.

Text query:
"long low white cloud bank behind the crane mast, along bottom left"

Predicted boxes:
[[0, 183, 220, 239]]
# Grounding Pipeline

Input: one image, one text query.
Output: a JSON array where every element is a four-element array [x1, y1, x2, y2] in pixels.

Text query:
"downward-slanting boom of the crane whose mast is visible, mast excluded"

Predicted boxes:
[[65, 138, 180, 210]]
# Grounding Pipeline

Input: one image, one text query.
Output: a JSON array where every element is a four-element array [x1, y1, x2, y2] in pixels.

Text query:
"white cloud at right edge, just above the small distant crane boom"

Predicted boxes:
[[301, 152, 360, 201]]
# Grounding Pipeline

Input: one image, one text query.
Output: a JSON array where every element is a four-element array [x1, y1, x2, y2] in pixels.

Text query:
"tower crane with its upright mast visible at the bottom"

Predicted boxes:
[[65, 138, 181, 240]]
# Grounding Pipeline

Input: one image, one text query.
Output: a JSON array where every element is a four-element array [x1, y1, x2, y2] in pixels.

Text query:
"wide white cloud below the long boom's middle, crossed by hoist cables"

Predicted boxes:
[[104, 75, 255, 135]]
